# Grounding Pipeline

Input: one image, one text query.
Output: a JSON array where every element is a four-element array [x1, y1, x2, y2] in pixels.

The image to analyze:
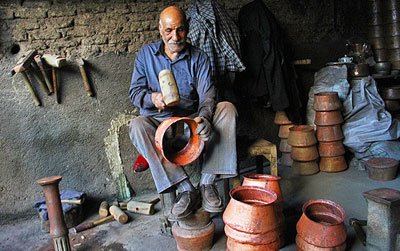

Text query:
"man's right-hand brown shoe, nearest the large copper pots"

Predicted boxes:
[[200, 184, 224, 213]]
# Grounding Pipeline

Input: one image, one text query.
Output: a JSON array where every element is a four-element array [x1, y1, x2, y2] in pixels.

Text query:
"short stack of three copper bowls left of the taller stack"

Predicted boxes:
[[288, 125, 319, 175]]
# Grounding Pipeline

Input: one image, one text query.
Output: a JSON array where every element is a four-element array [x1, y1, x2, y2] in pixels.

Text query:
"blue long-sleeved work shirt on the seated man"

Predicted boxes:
[[129, 41, 215, 121]]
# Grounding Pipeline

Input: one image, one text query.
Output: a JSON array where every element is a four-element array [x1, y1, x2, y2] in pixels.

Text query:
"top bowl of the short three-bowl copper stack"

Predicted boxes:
[[288, 125, 317, 147]]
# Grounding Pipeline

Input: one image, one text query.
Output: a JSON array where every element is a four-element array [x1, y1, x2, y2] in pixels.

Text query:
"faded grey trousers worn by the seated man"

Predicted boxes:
[[129, 102, 237, 193]]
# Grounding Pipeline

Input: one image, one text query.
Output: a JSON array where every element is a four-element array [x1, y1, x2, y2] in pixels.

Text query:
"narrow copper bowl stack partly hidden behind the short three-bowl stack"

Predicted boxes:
[[274, 111, 293, 166]]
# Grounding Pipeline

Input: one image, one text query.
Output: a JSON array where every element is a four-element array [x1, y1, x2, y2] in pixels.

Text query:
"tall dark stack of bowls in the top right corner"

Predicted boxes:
[[368, 0, 400, 70]]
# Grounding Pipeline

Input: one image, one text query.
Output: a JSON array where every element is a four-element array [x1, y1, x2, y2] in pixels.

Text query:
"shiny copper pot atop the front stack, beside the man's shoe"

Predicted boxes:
[[222, 186, 278, 234]]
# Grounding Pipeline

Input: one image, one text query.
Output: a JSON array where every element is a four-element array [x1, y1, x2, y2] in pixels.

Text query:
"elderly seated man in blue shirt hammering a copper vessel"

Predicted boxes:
[[129, 6, 237, 221]]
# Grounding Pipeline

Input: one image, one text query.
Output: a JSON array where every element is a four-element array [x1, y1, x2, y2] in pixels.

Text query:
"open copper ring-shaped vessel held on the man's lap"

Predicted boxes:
[[155, 117, 204, 166]]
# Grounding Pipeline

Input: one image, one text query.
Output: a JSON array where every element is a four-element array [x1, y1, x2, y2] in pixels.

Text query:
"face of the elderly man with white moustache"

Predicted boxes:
[[159, 17, 187, 53]]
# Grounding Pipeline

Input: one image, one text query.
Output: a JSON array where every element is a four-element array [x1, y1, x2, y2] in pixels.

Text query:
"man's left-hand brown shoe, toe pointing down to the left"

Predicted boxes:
[[168, 190, 200, 221]]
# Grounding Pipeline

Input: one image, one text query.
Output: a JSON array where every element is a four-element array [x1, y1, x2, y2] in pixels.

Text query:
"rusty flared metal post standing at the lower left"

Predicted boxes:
[[36, 176, 71, 251]]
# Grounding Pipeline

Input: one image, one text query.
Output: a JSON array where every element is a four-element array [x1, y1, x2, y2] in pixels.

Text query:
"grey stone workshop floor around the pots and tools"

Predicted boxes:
[[0, 163, 400, 251]]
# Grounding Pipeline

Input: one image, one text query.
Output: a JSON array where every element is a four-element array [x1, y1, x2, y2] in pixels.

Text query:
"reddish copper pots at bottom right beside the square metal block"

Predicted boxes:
[[296, 199, 347, 251]]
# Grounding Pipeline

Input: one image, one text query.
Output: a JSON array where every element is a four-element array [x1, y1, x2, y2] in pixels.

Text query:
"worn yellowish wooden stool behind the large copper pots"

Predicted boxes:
[[224, 138, 278, 202]]
